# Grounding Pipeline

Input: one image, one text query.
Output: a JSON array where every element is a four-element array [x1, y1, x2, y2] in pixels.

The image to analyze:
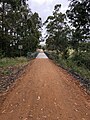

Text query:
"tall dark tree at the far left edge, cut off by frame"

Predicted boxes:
[[0, 0, 22, 55]]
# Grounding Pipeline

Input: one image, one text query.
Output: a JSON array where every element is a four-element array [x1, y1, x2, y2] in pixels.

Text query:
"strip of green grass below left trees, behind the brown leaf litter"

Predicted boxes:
[[0, 57, 28, 67]]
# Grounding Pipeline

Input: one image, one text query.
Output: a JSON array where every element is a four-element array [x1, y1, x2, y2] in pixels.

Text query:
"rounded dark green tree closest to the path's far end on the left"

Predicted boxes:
[[23, 12, 42, 51]]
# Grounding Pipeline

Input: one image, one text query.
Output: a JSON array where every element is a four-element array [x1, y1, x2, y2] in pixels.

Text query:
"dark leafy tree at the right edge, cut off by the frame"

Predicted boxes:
[[67, 0, 90, 51]]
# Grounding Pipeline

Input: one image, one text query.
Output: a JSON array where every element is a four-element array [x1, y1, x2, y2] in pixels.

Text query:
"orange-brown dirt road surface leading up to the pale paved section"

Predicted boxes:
[[0, 54, 90, 120]]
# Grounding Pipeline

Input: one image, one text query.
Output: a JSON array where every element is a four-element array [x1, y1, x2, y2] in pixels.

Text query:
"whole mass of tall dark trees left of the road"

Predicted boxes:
[[0, 0, 41, 57]]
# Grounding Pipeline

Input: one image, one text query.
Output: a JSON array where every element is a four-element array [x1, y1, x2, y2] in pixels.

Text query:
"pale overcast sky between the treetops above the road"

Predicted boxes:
[[28, 0, 69, 22]]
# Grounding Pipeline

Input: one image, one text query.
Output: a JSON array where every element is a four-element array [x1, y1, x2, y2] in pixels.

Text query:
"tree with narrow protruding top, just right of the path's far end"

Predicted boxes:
[[45, 4, 70, 57]]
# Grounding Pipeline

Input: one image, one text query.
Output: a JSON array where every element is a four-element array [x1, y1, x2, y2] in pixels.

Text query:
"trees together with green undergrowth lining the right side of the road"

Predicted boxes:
[[44, 0, 90, 89]]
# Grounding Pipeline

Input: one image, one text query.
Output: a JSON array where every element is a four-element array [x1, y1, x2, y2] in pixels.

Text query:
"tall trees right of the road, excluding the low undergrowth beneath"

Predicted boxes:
[[44, 0, 90, 58]]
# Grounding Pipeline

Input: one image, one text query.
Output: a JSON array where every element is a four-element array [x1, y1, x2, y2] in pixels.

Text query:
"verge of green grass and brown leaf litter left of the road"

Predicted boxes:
[[0, 57, 28, 93]]
